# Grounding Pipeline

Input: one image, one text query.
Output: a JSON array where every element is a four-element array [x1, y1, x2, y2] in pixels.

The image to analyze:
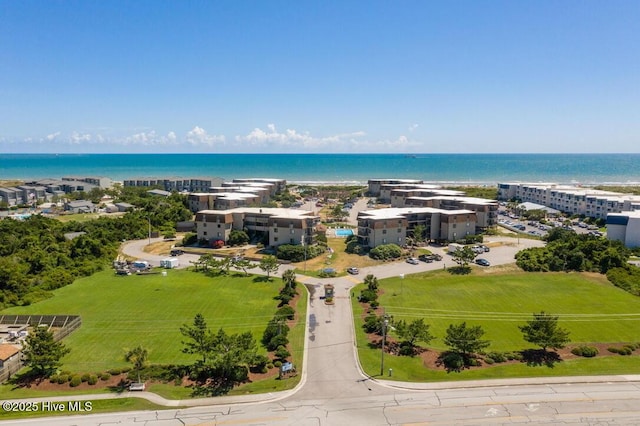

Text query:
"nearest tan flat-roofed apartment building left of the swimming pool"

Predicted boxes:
[[195, 207, 320, 247]]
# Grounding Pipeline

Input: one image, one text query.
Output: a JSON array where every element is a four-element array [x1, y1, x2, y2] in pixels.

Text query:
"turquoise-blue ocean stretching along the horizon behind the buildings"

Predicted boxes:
[[0, 154, 640, 184]]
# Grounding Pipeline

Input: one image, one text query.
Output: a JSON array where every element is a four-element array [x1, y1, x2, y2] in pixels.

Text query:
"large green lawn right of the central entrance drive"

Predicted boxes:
[[353, 270, 640, 380]]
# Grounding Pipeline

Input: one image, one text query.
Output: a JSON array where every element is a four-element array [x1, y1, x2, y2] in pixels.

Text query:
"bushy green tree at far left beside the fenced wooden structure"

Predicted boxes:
[[22, 327, 70, 378]]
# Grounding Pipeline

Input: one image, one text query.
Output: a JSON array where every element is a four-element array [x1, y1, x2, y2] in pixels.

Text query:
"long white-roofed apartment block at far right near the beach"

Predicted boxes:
[[498, 183, 640, 219]]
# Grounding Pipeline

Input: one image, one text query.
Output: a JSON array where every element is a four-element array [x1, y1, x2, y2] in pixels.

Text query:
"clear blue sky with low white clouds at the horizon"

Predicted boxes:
[[0, 0, 640, 153]]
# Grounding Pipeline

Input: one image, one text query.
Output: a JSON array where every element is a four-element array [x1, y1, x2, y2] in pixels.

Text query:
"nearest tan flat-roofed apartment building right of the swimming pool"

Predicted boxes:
[[357, 207, 476, 248]]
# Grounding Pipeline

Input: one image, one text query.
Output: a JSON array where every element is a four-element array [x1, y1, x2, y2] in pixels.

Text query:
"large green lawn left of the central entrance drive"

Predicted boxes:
[[3, 270, 296, 372]]
